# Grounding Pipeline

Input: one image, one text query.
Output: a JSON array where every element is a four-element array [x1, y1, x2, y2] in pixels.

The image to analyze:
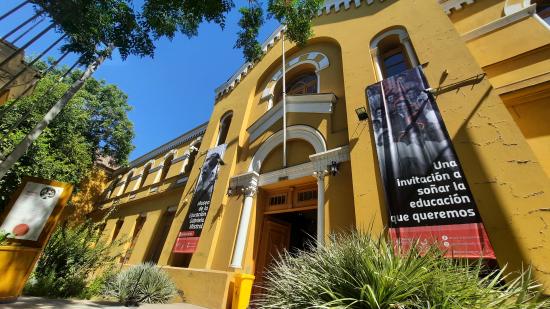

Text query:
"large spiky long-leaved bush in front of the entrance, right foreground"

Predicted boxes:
[[255, 233, 550, 309]]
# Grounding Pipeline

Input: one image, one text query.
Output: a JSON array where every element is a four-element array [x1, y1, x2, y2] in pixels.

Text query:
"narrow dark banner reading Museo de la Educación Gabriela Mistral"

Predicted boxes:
[[173, 144, 227, 253]]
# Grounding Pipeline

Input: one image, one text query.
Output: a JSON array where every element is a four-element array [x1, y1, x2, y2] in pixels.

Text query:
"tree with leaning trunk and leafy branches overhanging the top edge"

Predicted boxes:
[[0, 0, 322, 180]]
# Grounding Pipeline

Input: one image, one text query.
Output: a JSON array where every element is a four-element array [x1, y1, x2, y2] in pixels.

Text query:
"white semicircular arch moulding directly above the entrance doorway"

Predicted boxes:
[[248, 125, 327, 175]]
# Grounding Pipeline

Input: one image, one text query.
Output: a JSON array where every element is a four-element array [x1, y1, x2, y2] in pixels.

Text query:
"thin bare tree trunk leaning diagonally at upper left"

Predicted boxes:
[[0, 45, 113, 180]]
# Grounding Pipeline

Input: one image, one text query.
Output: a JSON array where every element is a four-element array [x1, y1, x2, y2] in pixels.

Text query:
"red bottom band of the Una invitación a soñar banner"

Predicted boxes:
[[390, 223, 496, 259]]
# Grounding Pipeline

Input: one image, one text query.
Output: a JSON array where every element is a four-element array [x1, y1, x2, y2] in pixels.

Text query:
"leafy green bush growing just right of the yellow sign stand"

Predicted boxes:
[[24, 221, 120, 298]]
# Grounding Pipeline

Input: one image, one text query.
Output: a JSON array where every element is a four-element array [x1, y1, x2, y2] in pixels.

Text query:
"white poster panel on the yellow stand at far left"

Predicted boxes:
[[0, 181, 64, 241]]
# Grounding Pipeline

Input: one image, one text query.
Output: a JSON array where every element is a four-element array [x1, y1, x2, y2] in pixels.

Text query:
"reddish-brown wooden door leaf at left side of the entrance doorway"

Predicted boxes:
[[253, 217, 291, 294]]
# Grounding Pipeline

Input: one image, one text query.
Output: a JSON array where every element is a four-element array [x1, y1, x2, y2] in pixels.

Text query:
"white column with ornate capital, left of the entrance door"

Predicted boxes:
[[230, 172, 258, 268]]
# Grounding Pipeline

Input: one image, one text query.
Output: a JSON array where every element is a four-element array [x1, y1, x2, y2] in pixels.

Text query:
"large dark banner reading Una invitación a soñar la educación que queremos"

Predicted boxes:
[[367, 67, 495, 258]]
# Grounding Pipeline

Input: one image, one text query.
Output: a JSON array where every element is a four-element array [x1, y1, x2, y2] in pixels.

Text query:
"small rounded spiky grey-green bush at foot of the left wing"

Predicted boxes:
[[104, 263, 177, 306]]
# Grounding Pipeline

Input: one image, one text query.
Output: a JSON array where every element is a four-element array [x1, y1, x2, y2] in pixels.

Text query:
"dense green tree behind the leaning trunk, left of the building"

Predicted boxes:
[[0, 63, 134, 205]]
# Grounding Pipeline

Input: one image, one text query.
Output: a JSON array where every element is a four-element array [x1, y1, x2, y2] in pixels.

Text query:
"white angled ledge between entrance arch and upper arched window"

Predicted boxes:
[[246, 93, 338, 142]]
